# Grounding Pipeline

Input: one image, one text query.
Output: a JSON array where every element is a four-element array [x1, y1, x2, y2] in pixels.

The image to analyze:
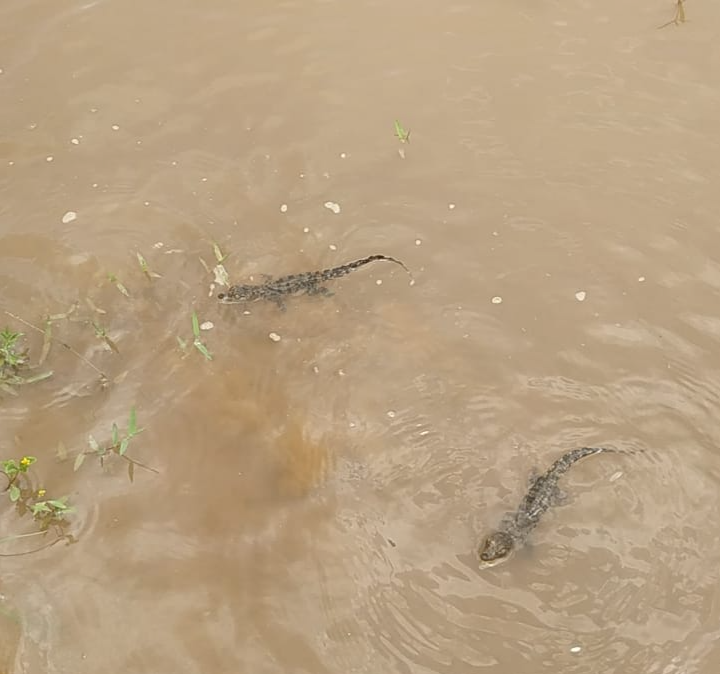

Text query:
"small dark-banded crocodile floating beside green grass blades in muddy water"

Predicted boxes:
[[218, 255, 412, 310]]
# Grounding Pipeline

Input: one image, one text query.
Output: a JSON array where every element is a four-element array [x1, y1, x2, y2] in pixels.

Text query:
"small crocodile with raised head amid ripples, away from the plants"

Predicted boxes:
[[478, 447, 616, 568]]
